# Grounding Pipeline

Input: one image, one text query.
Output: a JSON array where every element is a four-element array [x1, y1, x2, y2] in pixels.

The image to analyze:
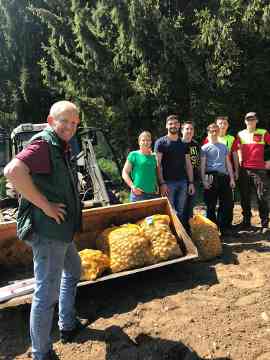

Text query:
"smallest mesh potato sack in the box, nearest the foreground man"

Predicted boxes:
[[79, 249, 110, 280]]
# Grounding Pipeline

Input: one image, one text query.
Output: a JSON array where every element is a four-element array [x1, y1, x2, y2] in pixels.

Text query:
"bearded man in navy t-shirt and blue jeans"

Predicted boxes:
[[155, 115, 195, 225]]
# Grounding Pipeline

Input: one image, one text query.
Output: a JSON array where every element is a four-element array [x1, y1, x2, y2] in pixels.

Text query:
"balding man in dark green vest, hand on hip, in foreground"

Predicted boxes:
[[4, 101, 86, 360]]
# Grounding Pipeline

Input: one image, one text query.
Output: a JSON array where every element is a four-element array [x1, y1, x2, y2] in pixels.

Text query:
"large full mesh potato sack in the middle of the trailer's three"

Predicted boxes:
[[96, 224, 152, 273]]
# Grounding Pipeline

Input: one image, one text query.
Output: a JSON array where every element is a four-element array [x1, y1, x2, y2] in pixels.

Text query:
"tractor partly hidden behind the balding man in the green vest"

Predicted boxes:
[[0, 123, 121, 208]]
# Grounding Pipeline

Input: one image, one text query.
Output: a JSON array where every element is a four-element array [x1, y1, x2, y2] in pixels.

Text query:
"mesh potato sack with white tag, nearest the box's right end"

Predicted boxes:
[[140, 215, 183, 263]]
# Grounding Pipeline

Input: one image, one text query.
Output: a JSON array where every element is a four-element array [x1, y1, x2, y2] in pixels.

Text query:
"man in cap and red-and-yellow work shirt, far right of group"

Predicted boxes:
[[234, 112, 270, 234]]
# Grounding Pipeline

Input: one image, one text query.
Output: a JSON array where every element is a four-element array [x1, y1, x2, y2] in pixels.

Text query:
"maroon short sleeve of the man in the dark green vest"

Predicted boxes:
[[16, 140, 51, 174]]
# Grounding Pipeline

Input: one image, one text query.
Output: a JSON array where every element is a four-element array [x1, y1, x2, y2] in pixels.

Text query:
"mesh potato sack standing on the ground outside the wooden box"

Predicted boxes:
[[189, 214, 222, 260]]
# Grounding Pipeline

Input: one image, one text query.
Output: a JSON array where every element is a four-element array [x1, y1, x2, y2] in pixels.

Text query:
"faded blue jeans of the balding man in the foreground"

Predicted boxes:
[[28, 234, 81, 360]]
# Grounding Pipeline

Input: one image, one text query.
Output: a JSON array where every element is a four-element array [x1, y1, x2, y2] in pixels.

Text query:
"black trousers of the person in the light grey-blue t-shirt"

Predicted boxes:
[[204, 172, 233, 230]]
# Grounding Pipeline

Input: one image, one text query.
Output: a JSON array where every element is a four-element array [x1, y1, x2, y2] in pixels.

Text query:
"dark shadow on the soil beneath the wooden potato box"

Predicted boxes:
[[74, 261, 218, 318]]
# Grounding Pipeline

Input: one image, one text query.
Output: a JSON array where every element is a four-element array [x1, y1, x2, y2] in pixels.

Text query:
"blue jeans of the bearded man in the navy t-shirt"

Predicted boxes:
[[166, 180, 187, 225]]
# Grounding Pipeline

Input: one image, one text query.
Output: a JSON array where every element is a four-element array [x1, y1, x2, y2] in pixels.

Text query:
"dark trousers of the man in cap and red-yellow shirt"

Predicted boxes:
[[239, 168, 269, 227]]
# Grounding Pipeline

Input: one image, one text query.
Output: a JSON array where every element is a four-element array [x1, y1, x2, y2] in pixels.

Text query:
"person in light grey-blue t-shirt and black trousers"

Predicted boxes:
[[201, 123, 235, 235]]
